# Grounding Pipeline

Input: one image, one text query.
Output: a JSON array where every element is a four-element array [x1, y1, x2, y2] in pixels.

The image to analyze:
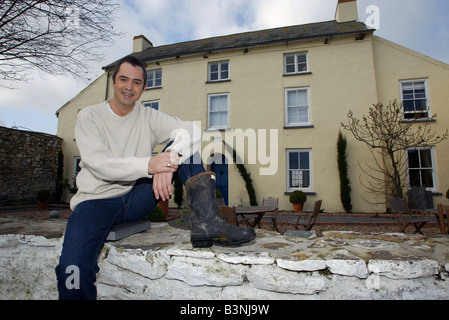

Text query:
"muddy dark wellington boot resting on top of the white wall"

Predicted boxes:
[[185, 171, 256, 248]]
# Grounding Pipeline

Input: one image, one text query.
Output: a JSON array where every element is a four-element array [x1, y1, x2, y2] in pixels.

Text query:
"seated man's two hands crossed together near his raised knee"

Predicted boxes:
[[148, 152, 179, 201]]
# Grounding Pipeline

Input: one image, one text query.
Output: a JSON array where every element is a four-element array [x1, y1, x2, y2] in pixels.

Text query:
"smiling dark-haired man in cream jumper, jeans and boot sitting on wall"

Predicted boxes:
[[56, 56, 256, 299]]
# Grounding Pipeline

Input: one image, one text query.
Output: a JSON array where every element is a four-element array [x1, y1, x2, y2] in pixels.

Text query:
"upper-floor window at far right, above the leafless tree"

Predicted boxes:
[[399, 79, 430, 120]]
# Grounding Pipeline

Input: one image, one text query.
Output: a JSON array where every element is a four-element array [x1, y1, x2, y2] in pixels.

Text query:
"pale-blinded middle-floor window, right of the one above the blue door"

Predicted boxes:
[[285, 88, 311, 126]]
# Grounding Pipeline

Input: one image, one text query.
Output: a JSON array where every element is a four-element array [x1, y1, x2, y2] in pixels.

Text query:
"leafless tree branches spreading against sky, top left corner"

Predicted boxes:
[[0, 0, 121, 83]]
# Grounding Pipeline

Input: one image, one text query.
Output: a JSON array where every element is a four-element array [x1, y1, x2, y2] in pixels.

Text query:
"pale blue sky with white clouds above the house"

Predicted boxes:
[[0, 0, 449, 134]]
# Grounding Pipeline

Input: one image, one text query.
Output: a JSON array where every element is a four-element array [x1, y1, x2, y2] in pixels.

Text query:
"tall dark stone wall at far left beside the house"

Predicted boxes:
[[0, 127, 62, 205]]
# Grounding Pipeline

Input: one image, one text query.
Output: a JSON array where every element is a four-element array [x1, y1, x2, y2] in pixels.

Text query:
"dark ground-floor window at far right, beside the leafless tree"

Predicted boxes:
[[407, 147, 438, 192]]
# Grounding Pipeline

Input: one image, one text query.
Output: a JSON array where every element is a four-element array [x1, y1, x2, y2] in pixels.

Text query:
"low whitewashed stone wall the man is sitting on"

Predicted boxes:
[[0, 221, 449, 300]]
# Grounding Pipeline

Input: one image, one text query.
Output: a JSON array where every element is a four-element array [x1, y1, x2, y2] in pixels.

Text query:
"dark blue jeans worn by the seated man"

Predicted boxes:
[[55, 153, 205, 300]]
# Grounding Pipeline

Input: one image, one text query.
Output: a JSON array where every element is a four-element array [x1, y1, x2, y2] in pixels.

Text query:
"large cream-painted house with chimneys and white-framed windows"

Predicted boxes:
[[57, 0, 449, 212]]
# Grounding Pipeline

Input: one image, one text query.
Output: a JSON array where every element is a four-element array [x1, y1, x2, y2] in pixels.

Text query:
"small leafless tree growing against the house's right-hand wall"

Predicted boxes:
[[341, 100, 448, 198]]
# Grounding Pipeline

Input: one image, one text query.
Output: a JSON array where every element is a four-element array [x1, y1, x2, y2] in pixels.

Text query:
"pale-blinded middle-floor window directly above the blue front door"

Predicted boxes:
[[208, 93, 229, 129]]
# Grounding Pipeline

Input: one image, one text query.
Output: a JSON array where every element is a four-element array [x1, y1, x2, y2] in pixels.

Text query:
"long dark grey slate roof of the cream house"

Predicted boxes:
[[104, 20, 374, 69]]
